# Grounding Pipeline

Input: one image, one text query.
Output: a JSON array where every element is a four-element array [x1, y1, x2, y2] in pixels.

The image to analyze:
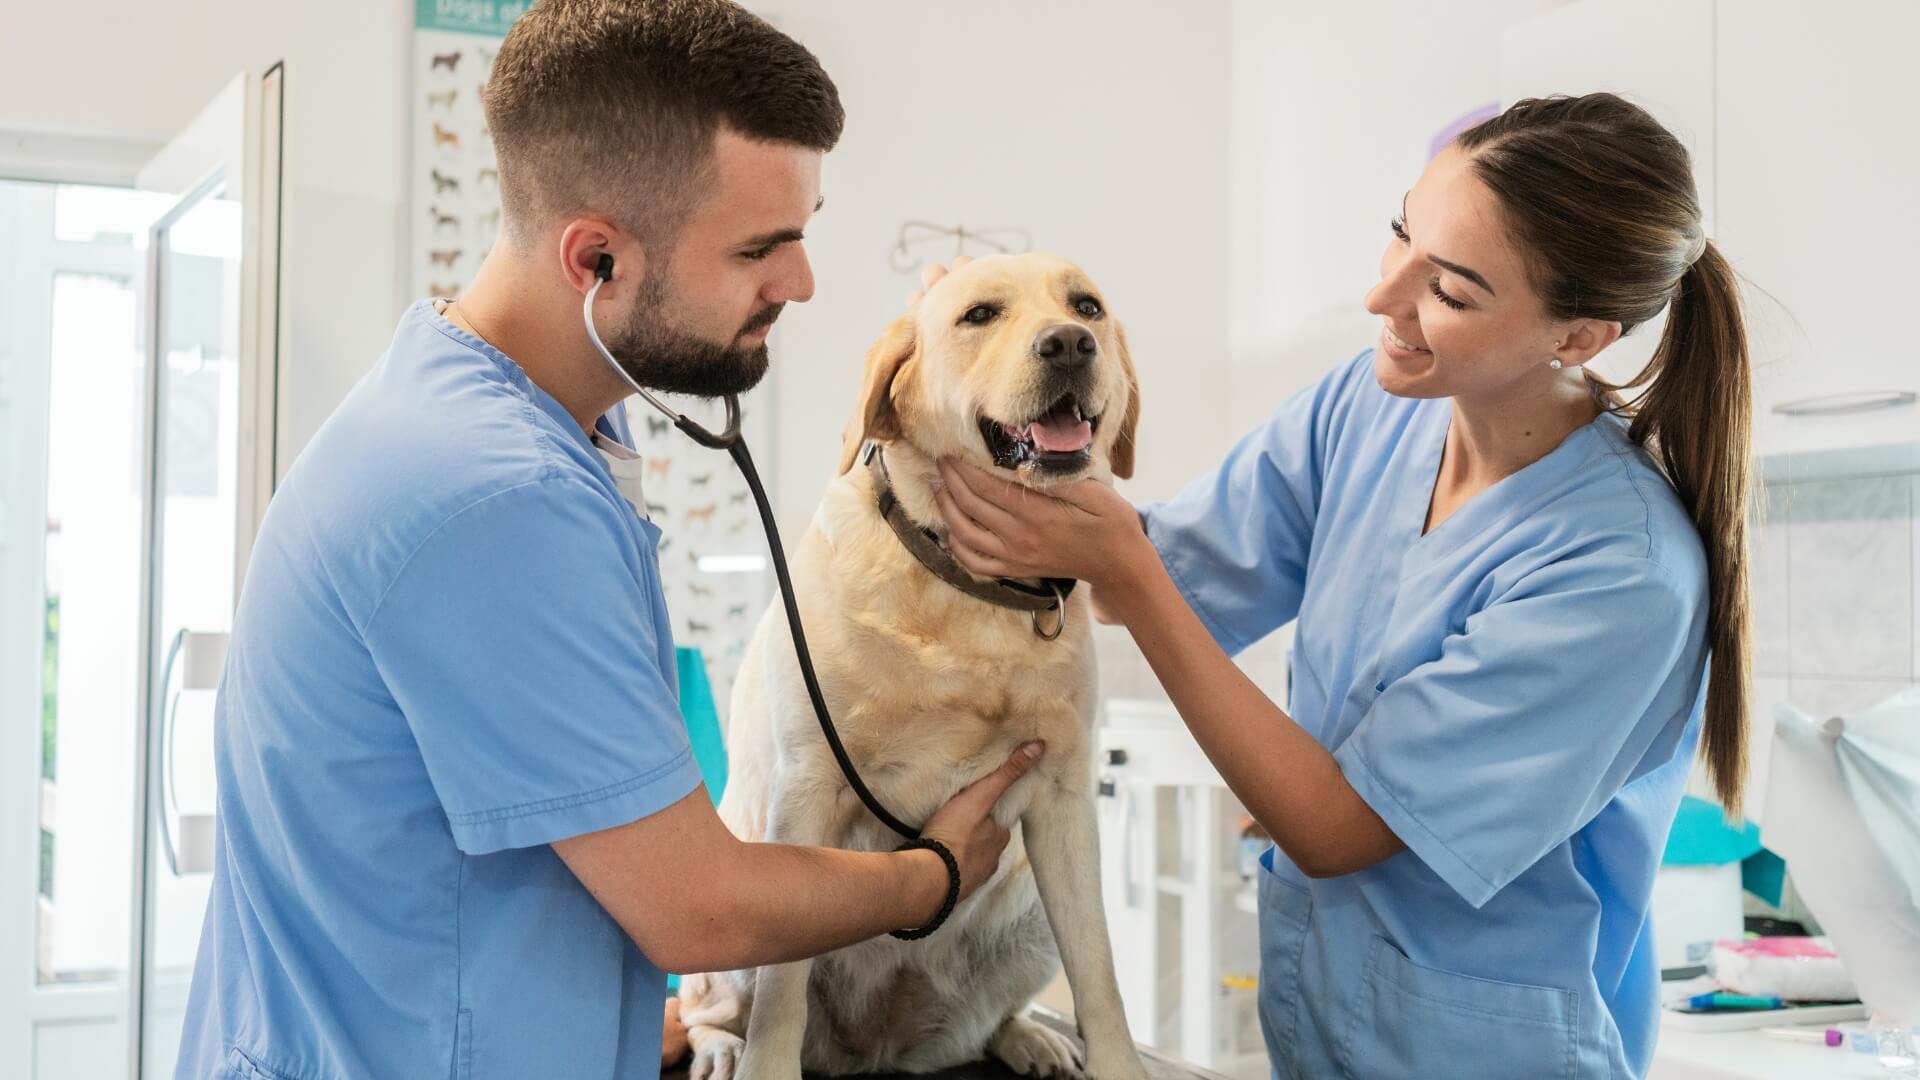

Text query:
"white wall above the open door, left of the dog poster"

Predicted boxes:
[[0, 0, 413, 457]]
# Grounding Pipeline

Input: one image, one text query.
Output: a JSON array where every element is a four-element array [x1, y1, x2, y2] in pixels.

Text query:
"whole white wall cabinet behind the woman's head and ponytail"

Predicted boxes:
[[1500, 0, 1920, 455]]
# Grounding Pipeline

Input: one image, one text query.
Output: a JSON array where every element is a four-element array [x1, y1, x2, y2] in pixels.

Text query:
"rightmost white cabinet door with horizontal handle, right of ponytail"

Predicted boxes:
[[1711, 0, 1920, 454]]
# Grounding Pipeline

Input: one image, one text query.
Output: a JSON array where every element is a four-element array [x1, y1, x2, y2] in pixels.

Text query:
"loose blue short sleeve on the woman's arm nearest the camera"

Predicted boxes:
[[1334, 555, 1699, 907]]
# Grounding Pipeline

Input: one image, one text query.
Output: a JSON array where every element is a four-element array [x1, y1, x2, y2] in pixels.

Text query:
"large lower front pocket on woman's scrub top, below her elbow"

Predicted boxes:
[[1346, 936, 1580, 1080]]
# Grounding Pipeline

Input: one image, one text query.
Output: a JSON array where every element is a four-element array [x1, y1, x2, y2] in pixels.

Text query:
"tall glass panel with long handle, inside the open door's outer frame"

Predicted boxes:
[[134, 166, 240, 1076]]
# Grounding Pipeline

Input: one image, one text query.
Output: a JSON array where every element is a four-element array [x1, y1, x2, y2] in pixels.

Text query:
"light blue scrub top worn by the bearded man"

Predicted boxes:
[[177, 304, 699, 1080]]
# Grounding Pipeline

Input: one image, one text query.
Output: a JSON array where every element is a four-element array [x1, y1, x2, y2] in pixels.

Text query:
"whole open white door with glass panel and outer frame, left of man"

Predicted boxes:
[[127, 67, 280, 1076]]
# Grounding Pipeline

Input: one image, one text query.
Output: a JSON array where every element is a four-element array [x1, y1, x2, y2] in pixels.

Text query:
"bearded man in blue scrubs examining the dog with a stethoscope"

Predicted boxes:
[[177, 0, 1037, 1080]]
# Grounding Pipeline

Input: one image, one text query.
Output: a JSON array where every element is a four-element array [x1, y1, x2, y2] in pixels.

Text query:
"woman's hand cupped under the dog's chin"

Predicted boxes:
[[933, 457, 1158, 590]]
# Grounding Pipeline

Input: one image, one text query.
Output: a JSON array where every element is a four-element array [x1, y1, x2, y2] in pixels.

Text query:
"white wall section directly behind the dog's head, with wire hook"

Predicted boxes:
[[772, 0, 1229, 521]]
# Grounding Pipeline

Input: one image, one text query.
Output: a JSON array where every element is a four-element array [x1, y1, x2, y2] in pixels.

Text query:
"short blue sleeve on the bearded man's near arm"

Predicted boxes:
[[367, 473, 699, 855]]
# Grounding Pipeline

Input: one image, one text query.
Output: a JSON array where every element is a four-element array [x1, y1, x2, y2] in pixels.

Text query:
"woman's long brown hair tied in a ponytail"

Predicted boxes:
[[1457, 94, 1753, 815]]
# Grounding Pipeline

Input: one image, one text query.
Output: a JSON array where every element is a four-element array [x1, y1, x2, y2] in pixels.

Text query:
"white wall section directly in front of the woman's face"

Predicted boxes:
[[1227, 0, 1578, 432]]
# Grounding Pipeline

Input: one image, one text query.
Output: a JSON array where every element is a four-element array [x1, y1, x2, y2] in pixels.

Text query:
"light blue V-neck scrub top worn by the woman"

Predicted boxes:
[[1144, 350, 1707, 1080]]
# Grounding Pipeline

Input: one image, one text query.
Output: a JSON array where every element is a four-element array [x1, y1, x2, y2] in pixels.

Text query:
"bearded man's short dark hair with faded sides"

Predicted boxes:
[[484, 0, 847, 246]]
